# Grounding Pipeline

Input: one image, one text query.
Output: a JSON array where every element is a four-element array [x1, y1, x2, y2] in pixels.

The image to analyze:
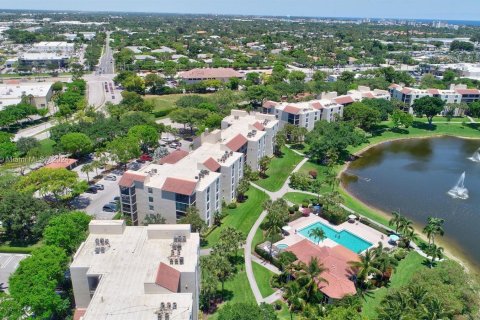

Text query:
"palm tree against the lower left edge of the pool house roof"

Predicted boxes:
[[296, 257, 328, 302]]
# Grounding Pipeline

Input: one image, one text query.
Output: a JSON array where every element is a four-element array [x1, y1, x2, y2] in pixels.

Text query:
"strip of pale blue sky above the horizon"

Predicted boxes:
[[0, 0, 480, 20]]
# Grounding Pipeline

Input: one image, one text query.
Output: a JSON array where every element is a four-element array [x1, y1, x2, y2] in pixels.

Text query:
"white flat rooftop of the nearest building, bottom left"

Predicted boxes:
[[70, 220, 200, 320]]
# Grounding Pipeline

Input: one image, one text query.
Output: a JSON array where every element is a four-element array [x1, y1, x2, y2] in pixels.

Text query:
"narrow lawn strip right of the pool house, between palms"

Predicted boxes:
[[362, 252, 426, 319]]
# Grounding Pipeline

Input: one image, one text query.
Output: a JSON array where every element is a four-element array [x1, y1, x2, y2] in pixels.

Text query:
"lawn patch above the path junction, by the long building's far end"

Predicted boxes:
[[255, 147, 302, 191]]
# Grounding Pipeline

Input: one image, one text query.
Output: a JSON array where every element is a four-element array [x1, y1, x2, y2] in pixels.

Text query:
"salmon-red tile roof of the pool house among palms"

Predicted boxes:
[[286, 239, 359, 299]]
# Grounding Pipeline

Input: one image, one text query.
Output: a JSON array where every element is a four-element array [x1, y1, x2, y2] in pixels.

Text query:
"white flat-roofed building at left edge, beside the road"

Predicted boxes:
[[0, 81, 53, 110]]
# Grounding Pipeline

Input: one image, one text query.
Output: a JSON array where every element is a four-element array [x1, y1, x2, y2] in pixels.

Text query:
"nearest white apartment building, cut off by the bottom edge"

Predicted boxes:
[[70, 220, 200, 320]]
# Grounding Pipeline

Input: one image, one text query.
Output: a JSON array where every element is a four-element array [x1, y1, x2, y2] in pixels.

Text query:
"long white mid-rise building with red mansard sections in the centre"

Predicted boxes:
[[119, 110, 278, 225]]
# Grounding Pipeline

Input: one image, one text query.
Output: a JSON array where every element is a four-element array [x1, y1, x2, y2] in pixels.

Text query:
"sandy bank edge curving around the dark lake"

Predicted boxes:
[[338, 134, 480, 274]]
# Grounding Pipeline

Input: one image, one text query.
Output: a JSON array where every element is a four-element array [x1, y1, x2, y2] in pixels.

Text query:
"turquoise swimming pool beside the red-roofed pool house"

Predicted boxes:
[[298, 222, 372, 253]]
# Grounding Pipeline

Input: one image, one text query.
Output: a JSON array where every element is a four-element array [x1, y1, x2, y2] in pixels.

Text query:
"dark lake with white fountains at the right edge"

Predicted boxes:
[[342, 137, 480, 268]]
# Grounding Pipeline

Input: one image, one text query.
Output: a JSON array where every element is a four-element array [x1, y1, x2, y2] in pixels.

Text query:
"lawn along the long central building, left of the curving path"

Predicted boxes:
[[205, 187, 268, 247]]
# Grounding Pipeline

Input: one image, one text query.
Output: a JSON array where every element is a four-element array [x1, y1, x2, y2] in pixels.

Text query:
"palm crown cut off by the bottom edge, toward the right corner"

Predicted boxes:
[[378, 285, 452, 320]]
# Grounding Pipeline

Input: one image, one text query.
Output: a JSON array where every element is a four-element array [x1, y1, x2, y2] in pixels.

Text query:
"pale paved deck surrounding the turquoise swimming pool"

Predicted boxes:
[[274, 214, 393, 254]]
